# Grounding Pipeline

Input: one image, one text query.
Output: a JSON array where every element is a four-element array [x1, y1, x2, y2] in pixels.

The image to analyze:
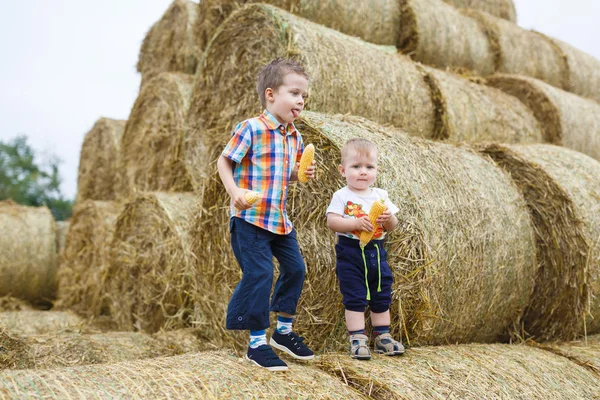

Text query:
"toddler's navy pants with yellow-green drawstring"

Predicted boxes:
[[335, 236, 394, 313]]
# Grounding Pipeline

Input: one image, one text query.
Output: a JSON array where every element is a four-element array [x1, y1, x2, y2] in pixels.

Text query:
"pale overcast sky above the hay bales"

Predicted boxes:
[[0, 0, 600, 198]]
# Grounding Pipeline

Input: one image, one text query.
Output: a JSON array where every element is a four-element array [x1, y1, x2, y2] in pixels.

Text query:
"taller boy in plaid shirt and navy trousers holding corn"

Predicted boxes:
[[217, 58, 315, 371]]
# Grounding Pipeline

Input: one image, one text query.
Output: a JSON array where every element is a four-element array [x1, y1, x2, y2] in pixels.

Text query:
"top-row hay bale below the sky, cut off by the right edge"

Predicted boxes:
[[538, 32, 600, 102]]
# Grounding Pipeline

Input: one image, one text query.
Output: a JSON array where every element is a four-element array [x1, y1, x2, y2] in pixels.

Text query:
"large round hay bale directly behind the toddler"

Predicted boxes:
[[193, 112, 536, 349]]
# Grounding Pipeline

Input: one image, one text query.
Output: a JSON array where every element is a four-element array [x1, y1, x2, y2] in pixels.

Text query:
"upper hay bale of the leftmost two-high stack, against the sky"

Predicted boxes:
[[76, 118, 125, 202]]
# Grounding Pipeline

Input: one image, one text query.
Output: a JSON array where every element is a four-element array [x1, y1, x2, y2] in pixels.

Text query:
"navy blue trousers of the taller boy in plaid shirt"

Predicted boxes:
[[226, 217, 305, 330]]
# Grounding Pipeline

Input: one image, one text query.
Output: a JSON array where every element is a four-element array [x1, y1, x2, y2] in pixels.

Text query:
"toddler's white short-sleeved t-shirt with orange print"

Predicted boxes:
[[326, 186, 399, 240]]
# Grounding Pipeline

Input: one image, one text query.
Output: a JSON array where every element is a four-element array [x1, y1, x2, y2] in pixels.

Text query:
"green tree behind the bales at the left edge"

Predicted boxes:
[[0, 135, 73, 221]]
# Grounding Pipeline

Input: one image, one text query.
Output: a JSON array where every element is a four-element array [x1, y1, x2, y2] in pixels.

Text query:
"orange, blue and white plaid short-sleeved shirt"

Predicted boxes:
[[221, 110, 304, 235]]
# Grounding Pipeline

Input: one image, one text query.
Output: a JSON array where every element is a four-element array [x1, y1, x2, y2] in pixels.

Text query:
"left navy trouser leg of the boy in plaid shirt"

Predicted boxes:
[[227, 217, 274, 330]]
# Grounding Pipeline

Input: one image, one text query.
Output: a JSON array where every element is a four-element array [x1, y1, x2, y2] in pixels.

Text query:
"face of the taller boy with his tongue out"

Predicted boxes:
[[265, 72, 308, 126]]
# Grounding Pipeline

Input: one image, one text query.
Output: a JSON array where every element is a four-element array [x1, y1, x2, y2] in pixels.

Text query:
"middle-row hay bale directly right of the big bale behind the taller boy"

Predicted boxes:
[[420, 66, 542, 143]]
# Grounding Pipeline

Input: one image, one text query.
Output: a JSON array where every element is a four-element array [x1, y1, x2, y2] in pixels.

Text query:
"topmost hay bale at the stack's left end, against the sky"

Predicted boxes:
[[137, 0, 202, 87]]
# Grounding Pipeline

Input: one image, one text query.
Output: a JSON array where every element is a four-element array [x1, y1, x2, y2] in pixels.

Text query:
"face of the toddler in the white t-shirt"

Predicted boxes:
[[339, 147, 377, 191]]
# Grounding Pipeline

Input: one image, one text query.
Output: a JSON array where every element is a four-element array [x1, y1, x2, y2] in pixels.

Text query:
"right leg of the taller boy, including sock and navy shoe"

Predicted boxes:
[[270, 229, 314, 360]]
